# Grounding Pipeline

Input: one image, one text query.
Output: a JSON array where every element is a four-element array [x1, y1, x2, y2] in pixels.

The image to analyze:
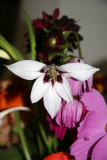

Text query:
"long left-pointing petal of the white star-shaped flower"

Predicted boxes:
[[6, 60, 46, 80]]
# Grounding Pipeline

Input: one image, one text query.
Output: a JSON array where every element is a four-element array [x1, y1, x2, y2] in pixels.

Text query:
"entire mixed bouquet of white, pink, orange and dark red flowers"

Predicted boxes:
[[0, 9, 107, 160]]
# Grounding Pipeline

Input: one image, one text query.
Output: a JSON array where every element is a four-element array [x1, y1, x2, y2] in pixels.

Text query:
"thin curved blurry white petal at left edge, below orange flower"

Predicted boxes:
[[0, 106, 31, 119]]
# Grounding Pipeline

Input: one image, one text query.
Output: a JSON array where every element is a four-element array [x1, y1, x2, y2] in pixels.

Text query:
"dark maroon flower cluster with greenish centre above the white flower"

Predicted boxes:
[[26, 9, 83, 64]]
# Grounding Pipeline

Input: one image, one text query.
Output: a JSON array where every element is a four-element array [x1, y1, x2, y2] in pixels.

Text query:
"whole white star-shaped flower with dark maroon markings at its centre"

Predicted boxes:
[[7, 60, 99, 118]]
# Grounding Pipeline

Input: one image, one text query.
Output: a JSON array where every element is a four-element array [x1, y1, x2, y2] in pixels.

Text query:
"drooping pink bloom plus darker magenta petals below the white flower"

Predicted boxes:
[[46, 99, 86, 140]]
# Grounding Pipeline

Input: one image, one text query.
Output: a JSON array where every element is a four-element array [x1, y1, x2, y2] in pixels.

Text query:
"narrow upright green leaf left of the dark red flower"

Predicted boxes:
[[23, 10, 36, 60]]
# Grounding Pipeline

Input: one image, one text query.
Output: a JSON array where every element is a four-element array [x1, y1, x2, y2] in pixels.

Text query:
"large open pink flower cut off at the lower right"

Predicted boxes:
[[70, 90, 107, 160]]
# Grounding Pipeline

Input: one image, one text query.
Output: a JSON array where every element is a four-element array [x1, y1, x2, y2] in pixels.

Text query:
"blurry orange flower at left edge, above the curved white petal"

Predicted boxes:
[[0, 78, 30, 110]]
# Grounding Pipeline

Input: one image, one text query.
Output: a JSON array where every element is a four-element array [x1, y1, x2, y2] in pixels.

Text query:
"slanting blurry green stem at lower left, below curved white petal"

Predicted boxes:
[[15, 111, 31, 160]]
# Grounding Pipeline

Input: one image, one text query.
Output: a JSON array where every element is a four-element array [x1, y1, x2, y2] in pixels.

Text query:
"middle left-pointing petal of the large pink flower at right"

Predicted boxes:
[[78, 111, 107, 139]]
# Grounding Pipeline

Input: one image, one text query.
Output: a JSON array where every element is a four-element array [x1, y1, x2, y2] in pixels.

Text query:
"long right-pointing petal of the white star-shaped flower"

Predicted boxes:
[[60, 63, 99, 81]]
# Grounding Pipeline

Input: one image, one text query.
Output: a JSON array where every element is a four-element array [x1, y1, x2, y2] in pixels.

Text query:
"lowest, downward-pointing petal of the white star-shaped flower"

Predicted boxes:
[[43, 86, 61, 119]]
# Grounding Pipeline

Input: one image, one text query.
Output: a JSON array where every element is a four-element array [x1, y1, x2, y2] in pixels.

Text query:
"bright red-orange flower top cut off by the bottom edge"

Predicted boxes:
[[43, 152, 75, 160]]
